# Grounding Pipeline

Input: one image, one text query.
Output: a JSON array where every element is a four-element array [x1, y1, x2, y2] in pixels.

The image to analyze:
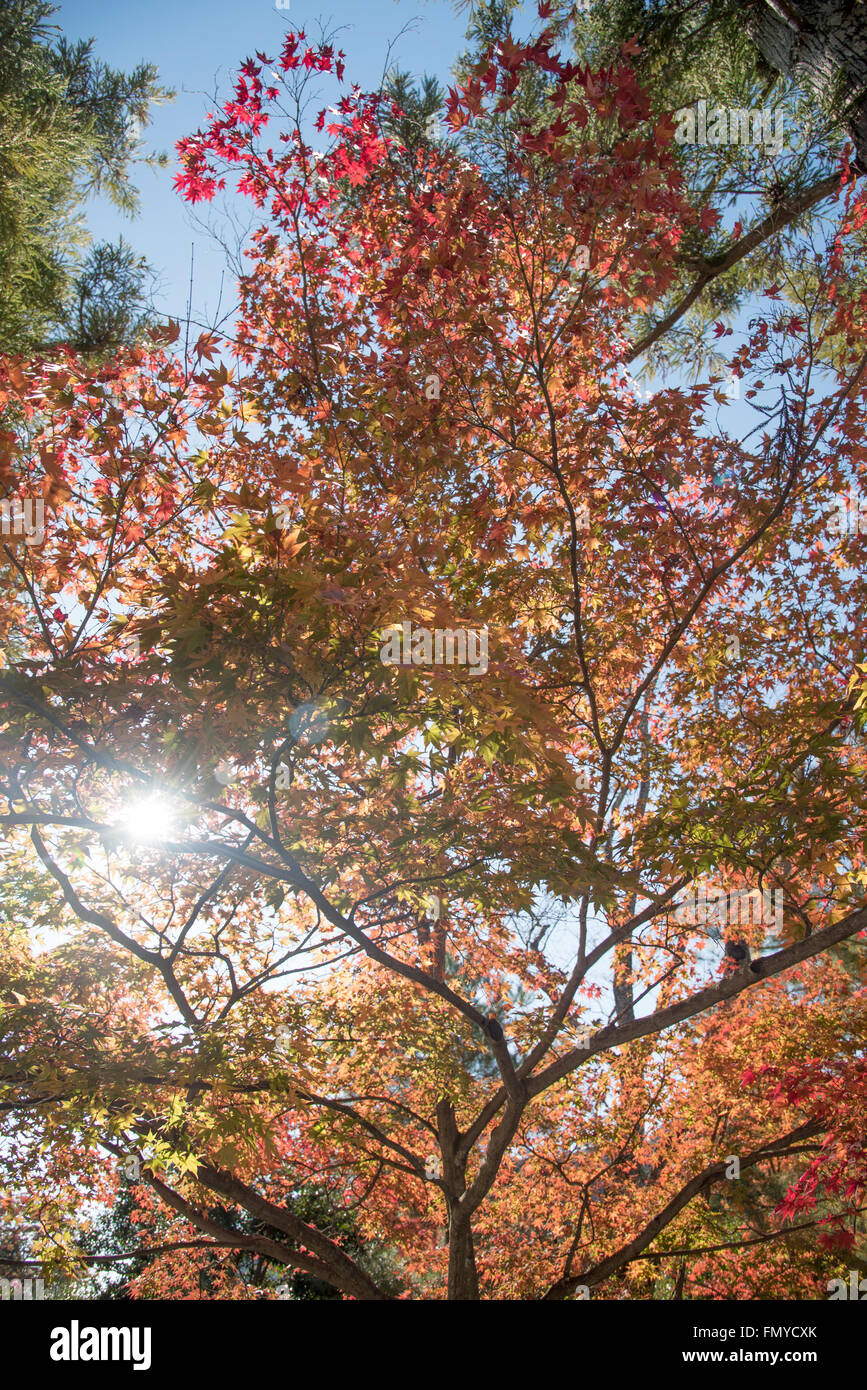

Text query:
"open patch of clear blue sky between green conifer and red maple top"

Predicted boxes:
[[54, 0, 467, 322]]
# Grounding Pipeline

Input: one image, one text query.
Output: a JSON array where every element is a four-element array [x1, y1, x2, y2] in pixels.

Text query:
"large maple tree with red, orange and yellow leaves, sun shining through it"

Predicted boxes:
[[0, 4, 867, 1300]]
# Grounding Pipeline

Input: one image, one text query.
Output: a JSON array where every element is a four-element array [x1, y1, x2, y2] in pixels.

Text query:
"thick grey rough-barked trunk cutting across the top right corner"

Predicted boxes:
[[746, 0, 867, 174]]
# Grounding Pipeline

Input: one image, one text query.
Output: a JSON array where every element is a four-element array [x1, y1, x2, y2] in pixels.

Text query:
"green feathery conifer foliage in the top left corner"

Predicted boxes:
[[0, 0, 171, 354]]
